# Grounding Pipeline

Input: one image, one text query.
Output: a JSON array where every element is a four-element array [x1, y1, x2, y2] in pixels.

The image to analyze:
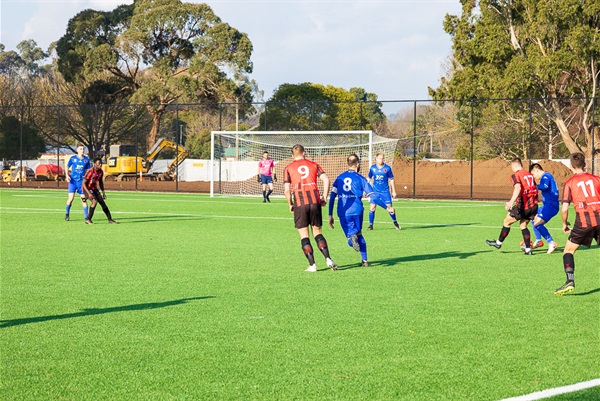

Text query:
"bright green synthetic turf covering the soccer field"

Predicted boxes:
[[0, 189, 600, 400]]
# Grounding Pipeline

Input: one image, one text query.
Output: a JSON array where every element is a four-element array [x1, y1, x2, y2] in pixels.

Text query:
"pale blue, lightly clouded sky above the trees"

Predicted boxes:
[[0, 0, 460, 114]]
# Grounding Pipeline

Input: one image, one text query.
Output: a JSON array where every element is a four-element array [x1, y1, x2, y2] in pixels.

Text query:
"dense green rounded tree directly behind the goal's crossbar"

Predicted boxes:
[[260, 82, 385, 131]]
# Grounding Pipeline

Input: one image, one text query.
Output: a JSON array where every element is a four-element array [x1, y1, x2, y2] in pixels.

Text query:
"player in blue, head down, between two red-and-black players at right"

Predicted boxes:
[[529, 163, 558, 253]]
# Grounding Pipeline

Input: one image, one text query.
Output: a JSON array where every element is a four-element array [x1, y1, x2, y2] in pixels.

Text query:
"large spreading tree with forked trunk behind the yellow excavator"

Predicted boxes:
[[57, 0, 252, 148]]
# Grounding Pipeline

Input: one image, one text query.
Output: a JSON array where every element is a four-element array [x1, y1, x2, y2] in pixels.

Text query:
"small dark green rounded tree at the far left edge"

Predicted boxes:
[[0, 116, 45, 160]]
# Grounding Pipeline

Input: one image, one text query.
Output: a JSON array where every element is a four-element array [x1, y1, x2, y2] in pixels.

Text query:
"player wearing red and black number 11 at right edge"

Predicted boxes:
[[554, 152, 600, 295]]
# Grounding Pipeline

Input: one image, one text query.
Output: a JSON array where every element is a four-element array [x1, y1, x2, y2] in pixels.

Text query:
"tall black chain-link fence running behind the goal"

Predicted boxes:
[[0, 98, 600, 199]]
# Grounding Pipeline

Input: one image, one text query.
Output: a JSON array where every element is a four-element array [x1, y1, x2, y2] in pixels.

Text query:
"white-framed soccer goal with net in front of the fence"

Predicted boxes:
[[210, 131, 398, 197]]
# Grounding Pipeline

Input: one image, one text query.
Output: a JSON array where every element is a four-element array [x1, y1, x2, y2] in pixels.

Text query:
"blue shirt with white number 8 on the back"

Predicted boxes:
[[329, 170, 373, 217]]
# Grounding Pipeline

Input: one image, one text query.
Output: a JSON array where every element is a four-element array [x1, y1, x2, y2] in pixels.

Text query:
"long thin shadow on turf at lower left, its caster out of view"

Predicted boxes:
[[0, 295, 215, 329]]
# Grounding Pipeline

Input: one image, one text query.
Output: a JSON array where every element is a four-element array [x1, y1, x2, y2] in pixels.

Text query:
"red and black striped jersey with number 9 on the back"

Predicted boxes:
[[283, 159, 325, 206]]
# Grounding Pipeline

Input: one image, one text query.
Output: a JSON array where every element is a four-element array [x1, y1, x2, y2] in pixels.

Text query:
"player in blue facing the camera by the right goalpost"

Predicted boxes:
[[367, 152, 400, 230]]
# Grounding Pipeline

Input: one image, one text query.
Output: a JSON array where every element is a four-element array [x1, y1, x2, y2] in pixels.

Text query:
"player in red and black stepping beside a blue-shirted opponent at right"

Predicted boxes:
[[485, 157, 538, 255]]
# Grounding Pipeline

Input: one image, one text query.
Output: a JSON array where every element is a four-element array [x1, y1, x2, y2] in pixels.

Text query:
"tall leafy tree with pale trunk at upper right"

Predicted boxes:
[[430, 0, 600, 157]]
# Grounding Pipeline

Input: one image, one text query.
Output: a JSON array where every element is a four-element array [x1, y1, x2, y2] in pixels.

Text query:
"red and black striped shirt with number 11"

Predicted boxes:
[[562, 172, 600, 228]]
